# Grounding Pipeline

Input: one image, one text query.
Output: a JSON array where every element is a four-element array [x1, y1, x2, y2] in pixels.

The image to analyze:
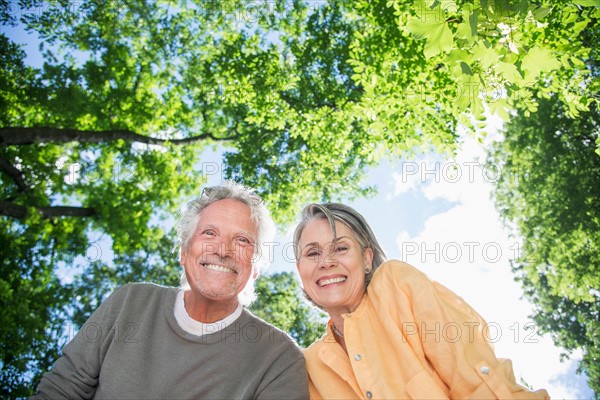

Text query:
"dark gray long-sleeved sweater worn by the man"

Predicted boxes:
[[33, 283, 308, 399]]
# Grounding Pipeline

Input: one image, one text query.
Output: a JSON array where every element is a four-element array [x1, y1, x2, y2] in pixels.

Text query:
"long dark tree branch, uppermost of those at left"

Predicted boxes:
[[0, 127, 236, 146]]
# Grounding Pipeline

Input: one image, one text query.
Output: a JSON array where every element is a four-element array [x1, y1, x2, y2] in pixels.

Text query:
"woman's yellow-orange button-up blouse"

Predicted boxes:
[[304, 261, 549, 399]]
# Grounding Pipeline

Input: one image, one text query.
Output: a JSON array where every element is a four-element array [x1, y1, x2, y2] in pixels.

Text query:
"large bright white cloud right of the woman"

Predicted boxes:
[[395, 135, 591, 398]]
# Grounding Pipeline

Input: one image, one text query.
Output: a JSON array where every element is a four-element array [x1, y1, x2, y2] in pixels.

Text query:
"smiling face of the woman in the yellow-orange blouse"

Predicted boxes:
[[296, 218, 373, 314]]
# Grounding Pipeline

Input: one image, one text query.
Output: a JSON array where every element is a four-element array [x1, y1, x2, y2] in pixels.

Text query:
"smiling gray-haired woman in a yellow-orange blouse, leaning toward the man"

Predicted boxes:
[[294, 203, 549, 399]]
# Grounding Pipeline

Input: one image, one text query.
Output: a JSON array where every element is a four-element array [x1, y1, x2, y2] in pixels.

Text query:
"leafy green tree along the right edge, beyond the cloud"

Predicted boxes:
[[490, 96, 600, 397]]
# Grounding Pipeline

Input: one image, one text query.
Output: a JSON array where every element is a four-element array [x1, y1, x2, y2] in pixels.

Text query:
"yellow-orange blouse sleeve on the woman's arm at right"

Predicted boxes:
[[381, 263, 549, 399]]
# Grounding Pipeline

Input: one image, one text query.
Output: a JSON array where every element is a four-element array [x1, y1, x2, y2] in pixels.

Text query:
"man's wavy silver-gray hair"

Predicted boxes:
[[177, 180, 275, 306]]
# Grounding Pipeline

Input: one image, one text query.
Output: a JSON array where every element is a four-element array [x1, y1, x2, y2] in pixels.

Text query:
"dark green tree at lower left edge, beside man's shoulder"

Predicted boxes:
[[0, 220, 72, 398]]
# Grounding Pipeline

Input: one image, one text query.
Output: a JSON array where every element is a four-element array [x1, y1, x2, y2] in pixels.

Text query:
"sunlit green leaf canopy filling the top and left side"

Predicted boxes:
[[0, 0, 600, 394]]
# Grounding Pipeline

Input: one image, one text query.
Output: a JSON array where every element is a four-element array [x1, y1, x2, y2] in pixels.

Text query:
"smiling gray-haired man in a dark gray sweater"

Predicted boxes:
[[34, 182, 308, 399]]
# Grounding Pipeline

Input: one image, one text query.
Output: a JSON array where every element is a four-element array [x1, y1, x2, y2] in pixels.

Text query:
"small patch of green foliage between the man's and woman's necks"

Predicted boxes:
[[250, 272, 327, 347]]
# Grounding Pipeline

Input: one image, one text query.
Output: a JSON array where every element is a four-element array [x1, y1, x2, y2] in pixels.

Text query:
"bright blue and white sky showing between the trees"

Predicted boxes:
[[5, 14, 593, 399]]
